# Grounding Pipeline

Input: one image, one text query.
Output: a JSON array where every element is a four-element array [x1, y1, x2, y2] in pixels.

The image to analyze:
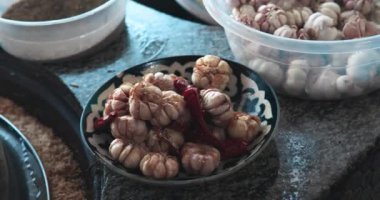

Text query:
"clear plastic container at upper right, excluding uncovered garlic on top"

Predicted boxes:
[[204, 0, 380, 100]]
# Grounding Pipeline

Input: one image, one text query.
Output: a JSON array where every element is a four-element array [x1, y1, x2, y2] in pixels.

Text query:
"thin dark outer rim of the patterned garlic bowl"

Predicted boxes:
[[80, 55, 280, 186]]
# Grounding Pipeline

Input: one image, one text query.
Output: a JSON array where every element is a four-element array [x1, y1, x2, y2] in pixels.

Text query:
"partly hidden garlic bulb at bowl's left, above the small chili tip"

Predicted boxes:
[[103, 83, 132, 117]]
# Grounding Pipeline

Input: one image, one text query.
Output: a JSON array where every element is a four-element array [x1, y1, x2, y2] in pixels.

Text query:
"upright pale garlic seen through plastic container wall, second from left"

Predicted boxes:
[[284, 60, 309, 96]]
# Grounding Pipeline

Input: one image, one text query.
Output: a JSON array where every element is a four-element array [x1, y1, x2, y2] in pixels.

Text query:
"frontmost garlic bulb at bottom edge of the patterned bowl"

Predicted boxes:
[[140, 153, 179, 179]]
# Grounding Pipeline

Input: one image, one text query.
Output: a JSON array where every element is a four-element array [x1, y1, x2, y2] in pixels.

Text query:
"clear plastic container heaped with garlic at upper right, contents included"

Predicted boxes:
[[204, 0, 380, 100]]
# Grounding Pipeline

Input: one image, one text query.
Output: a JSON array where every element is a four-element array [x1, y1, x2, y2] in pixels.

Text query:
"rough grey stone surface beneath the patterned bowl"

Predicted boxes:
[[2, 1, 380, 200]]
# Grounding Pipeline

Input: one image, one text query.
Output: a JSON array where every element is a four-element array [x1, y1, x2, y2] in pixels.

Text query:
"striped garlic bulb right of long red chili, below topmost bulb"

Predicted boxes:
[[200, 89, 233, 126]]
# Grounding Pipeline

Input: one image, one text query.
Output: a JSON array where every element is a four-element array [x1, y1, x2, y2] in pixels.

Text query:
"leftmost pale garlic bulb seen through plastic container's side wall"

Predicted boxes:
[[248, 58, 285, 87]]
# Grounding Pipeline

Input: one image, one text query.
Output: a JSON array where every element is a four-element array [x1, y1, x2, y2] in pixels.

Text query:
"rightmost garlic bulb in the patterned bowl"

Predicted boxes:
[[227, 112, 262, 142]]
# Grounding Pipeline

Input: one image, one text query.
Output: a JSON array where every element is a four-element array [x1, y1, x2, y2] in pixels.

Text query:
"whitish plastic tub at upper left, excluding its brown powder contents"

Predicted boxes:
[[0, 0, 126, 61]]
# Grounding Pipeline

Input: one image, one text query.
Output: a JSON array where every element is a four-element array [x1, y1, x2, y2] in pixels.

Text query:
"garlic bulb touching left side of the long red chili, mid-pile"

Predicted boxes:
[[150, 91, 186, 127]]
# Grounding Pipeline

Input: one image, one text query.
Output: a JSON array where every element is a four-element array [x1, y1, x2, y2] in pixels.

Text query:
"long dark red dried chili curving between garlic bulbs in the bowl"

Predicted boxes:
[[174, 79, 248, 159]]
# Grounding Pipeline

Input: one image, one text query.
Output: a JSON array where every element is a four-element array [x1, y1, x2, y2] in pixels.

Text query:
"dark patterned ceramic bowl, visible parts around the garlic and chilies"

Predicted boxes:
[[80, 56, 280, 186]]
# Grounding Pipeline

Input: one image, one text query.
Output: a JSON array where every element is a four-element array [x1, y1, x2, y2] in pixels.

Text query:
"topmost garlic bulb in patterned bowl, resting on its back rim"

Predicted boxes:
[[191, 55, 232, 90]]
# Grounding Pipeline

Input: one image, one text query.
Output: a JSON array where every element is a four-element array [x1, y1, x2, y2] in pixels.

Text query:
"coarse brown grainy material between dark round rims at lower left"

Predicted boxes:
[[0, 97, 85, 200]]
